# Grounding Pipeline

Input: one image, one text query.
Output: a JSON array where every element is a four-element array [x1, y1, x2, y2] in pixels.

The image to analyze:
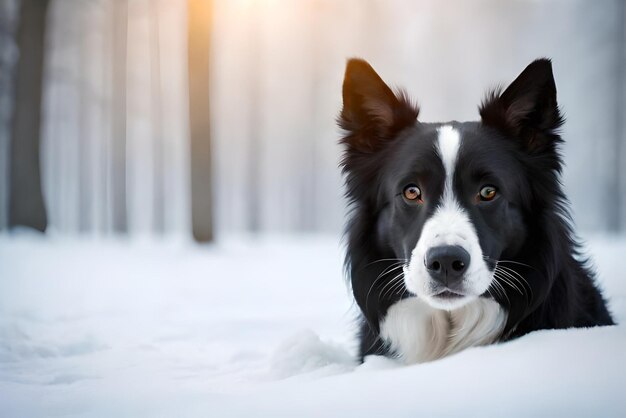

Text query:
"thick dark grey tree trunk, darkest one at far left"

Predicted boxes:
[[9, 0, 48, 231]]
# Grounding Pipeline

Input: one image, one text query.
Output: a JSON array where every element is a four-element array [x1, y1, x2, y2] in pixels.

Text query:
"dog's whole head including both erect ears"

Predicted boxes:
[[339, 59, 562, 309]]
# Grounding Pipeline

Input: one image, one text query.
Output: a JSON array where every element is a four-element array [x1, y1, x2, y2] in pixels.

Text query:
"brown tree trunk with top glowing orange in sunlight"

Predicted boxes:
[[187, 0, 213, 242]]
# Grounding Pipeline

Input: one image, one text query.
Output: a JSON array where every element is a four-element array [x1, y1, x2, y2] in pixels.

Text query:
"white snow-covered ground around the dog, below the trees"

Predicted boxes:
[[0, 236, 626, 418]]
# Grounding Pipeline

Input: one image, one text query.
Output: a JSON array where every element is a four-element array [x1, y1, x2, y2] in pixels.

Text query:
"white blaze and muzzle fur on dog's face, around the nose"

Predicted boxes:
[[404, 125, 492, 310]]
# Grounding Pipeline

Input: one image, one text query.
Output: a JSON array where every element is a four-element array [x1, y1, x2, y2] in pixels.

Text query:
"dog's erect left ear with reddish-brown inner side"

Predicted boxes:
[[338, 59, 419, 152]]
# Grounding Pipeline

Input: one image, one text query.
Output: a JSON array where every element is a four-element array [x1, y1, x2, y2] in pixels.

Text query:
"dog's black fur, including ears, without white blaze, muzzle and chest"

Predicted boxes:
[[338, 59, 613, 360]]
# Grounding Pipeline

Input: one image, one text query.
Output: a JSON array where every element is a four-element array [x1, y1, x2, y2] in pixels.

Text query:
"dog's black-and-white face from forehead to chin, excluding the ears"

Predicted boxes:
[[378, 123, 525, 309]]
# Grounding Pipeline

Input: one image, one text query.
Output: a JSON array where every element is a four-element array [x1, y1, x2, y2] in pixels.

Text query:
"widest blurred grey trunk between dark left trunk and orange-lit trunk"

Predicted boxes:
[[110, 0, 128, 233]]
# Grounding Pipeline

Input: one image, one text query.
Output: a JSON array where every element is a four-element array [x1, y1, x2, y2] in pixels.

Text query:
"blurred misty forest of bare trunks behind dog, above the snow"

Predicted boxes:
[[0, 0, 626, 236]]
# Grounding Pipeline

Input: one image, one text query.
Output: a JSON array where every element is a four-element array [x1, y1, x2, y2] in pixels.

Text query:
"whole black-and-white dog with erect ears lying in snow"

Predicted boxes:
[[339, 59, 613, 363]]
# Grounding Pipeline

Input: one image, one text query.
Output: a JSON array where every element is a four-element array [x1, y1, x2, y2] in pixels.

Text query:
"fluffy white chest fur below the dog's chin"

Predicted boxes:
[[380, 297, 507, 363]]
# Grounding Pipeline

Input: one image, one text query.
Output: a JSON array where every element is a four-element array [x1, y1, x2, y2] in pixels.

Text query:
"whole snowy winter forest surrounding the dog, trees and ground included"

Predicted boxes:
[[0, 0, 626, 417]]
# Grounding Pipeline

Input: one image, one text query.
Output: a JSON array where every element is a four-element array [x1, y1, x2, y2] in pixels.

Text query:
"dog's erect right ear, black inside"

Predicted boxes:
[[479, 58, 563, 152]]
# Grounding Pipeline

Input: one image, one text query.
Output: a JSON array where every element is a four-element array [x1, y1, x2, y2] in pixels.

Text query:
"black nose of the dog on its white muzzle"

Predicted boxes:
[[425, 245, 470, 286]]
